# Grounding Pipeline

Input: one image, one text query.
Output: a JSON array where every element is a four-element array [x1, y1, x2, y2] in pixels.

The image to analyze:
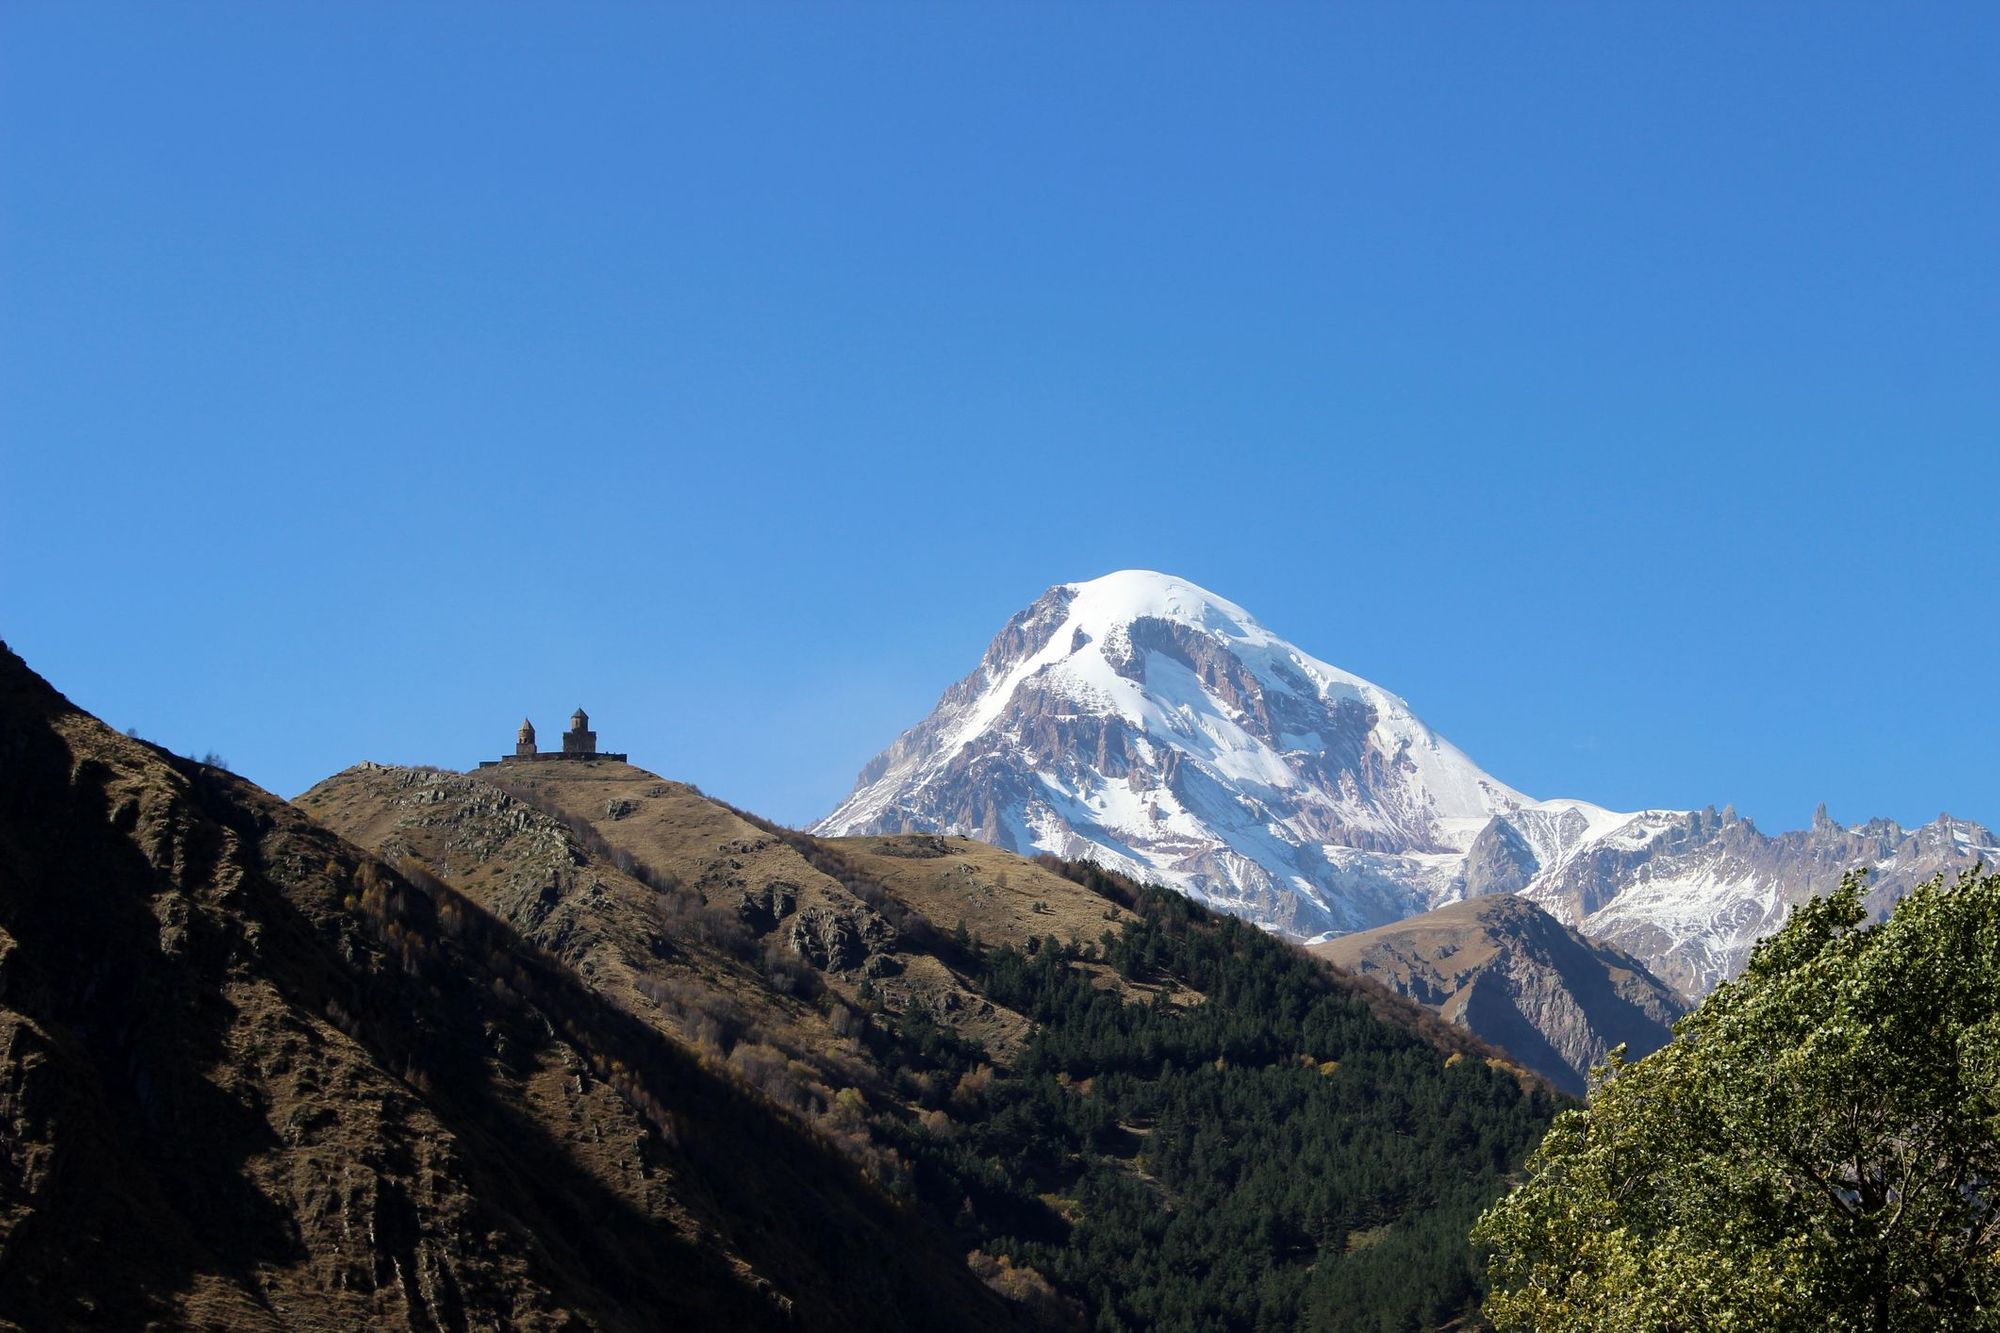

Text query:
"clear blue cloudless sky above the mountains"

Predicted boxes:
[[0, 0, 2000, 829]]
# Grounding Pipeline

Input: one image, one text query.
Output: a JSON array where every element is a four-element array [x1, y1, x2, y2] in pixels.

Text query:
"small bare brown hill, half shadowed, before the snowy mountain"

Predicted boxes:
[[1312, 893, 1688, 1095]]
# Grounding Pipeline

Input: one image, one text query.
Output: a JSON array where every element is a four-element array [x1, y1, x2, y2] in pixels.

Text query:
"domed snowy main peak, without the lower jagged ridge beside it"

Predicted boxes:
[[818, 570, 1530, 935]]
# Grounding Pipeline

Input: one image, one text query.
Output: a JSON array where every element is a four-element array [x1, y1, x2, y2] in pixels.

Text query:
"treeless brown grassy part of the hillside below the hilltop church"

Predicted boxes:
[[298, 761, 1536, 1104]]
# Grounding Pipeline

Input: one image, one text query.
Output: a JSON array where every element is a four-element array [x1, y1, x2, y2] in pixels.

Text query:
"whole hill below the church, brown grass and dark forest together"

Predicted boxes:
[[300, 761, 1554, 1329]]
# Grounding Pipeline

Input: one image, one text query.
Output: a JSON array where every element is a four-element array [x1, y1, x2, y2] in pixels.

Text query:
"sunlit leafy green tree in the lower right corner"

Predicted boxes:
[[1474, 871, 2000, 1331]]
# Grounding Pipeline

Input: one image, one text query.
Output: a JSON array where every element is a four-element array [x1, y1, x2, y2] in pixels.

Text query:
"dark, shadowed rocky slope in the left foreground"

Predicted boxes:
[[0, 648, 1012, 1329]]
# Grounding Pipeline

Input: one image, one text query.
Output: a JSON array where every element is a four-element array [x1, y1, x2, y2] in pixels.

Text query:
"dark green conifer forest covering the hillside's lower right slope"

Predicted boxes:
[[898, 871, 1556, 1329]]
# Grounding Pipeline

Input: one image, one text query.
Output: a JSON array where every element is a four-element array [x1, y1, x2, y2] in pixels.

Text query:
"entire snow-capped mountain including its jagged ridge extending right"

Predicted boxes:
[[814, 570, 2000, 995]]
